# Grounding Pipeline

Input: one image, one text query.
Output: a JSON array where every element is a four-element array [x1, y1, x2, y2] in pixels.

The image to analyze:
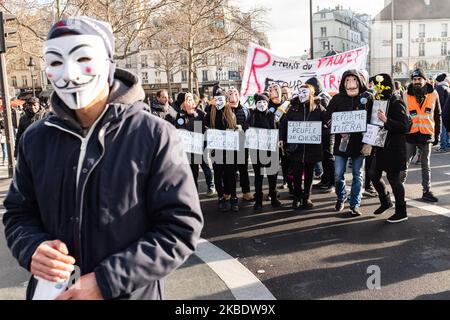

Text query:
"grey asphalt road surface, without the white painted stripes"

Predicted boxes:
[[0, 153, 450, 299]]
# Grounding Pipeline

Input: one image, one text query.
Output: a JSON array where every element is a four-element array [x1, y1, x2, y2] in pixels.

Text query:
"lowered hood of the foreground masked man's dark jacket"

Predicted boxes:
[[49, 68, 145, 131]]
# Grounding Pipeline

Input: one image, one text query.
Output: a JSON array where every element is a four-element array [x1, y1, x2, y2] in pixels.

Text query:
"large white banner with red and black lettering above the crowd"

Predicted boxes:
[[241, 43, 369, 107]]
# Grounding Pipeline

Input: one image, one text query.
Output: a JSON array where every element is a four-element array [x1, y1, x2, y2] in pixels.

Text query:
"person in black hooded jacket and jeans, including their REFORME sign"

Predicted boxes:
[[328, 70, 373, 217]]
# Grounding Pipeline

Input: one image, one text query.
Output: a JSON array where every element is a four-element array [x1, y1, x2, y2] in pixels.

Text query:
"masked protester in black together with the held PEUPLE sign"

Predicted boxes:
[[280, 84, 326, 210]]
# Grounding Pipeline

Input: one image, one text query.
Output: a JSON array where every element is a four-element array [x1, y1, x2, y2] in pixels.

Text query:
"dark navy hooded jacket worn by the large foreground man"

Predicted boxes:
[[3, 69, 203, 300]]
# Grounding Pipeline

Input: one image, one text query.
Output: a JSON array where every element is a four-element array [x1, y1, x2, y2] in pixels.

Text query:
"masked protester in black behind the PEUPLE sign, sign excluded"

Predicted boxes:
[[280, 84, 326, 210]]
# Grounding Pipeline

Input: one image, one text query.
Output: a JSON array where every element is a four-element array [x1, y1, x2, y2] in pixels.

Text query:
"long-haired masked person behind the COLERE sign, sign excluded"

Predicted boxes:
[[205, 86, 239, 212]]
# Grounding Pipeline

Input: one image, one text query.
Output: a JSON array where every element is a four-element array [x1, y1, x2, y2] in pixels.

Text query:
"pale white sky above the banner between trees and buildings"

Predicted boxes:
[[232, 0, 384, 57]]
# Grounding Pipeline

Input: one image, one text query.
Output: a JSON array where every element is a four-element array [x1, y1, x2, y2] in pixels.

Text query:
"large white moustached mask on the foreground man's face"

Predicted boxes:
[[44, 35, 112, 110]]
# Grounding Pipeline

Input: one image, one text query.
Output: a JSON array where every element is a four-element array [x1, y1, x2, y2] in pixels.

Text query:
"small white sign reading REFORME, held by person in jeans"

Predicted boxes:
[[331, 110, 367, 134]]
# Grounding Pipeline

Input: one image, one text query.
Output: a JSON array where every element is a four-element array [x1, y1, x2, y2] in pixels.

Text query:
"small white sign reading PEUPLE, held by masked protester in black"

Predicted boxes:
[[287, 121, 322, 144]]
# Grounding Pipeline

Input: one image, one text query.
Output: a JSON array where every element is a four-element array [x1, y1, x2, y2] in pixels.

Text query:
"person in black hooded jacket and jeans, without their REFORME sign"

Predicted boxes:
[[327, 70, 373, 217]]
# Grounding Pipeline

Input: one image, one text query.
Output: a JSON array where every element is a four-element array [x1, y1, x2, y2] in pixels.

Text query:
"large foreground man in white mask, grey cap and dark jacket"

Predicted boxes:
[[3, 17, 203, 300]]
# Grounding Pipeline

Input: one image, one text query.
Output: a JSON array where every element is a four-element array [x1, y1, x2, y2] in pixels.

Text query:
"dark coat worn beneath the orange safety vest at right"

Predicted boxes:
[[403, 83, 442, 144]]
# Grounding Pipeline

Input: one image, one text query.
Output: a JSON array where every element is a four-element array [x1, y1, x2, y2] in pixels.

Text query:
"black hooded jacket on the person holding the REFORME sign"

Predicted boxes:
[[327, 70, 373, 158]]
